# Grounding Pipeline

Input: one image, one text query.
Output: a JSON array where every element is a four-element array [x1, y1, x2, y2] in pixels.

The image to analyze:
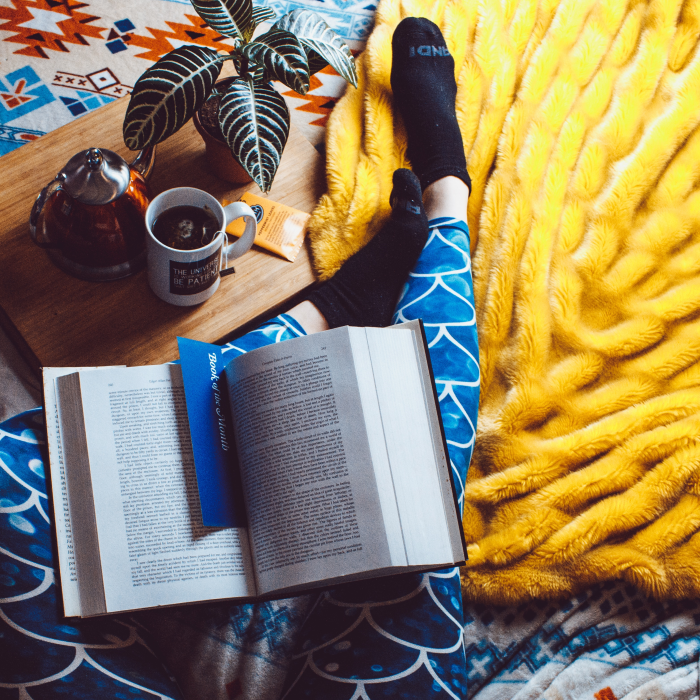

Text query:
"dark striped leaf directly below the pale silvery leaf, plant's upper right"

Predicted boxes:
[[241, 29, 309, 95]]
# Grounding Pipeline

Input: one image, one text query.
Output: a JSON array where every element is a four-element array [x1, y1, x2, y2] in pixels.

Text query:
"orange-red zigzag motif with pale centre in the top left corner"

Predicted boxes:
[[0, 0, 107, 58]]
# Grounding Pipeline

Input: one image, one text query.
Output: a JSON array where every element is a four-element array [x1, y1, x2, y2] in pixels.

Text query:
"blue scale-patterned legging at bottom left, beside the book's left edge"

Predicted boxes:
[[0, 409, 182, 700]]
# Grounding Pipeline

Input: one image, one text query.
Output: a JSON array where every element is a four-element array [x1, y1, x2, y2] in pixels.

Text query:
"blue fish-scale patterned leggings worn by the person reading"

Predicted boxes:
[[0, 219, 479, 700]]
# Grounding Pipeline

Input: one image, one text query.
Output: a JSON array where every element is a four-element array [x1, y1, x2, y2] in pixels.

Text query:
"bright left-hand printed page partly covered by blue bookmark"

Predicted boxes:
[[80, 365, 255, 612]]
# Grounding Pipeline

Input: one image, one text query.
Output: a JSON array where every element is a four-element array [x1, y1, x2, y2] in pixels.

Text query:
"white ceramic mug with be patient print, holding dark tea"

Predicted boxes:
[[146, 187, 257, 306]]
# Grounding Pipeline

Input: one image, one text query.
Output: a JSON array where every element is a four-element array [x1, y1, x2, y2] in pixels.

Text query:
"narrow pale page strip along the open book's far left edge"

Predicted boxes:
[[42, 367, 123, 617]]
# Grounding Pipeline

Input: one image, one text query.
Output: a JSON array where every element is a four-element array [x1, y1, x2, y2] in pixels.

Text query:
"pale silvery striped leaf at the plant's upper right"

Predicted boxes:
[[272, 9, 357, 87]]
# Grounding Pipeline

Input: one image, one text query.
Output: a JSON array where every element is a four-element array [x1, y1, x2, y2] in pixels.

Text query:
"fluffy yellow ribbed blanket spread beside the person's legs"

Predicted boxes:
[[311, 0, 700, 603]]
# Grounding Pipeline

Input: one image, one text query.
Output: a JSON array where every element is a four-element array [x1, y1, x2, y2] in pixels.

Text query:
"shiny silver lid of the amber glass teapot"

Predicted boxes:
[[61, 148, 131, 204]]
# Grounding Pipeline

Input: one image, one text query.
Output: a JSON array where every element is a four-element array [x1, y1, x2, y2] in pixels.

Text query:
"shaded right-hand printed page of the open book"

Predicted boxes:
[[226, 328, 392, 593]]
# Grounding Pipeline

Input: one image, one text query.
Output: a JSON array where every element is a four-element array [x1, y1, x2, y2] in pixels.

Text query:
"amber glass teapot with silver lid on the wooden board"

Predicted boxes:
[[29, 147, 155, 281]]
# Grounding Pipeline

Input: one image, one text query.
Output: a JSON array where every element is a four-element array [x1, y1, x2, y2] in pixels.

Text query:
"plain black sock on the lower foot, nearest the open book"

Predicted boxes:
[[308, 169, 428, 328]]
